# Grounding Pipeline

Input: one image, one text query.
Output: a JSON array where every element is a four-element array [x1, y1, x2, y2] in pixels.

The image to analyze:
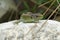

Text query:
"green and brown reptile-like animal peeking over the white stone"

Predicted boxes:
[[20, 12, 43, 23]]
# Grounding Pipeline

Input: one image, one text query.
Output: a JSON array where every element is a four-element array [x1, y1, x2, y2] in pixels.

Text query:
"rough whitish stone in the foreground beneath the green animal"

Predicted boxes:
[[0, 20, 60, 40]]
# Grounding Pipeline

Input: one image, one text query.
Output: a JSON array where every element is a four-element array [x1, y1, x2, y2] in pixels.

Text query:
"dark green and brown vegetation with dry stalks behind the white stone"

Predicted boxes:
[[1, 0, 60, 22]]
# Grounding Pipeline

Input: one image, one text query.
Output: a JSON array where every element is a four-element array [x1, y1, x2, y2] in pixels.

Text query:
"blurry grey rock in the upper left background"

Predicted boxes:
[[0, 0, 16, 18]]
